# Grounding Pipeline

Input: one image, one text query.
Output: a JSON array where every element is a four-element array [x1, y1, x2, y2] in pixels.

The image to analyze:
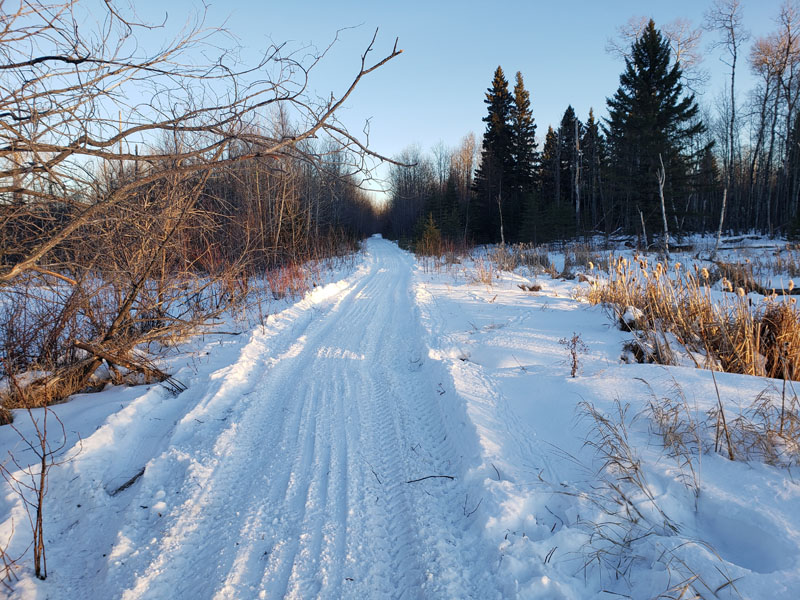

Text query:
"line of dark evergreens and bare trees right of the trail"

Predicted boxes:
[[387, 0, 800, 246]]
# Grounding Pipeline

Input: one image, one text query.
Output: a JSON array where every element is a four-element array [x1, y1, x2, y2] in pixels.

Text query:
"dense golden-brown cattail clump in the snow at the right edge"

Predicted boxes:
[[588, 258, 800, 379]]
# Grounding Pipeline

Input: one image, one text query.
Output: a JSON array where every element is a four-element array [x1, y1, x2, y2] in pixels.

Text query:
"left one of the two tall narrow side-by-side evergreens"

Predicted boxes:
[[470, 66, 514, 242]]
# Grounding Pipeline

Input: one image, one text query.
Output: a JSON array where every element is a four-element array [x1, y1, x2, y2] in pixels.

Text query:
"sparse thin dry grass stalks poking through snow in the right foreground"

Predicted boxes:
[[540, 398, 738, 599]]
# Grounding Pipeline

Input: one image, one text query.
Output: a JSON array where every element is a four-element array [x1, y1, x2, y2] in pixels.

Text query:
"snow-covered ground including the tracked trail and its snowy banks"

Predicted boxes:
[[0, 238, 800, 600]]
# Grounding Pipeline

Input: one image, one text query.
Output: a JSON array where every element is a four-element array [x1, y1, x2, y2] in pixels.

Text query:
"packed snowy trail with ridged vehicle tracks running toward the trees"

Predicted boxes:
[[39, 239, 499, 600]]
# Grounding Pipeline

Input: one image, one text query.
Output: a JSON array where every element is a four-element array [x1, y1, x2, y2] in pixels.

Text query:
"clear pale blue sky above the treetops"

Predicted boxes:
[[136, 0, 782, 196]]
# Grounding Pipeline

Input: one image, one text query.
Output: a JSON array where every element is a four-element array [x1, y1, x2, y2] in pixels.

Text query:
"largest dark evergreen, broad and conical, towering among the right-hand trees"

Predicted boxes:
[[605, 20, 705, 242]]
